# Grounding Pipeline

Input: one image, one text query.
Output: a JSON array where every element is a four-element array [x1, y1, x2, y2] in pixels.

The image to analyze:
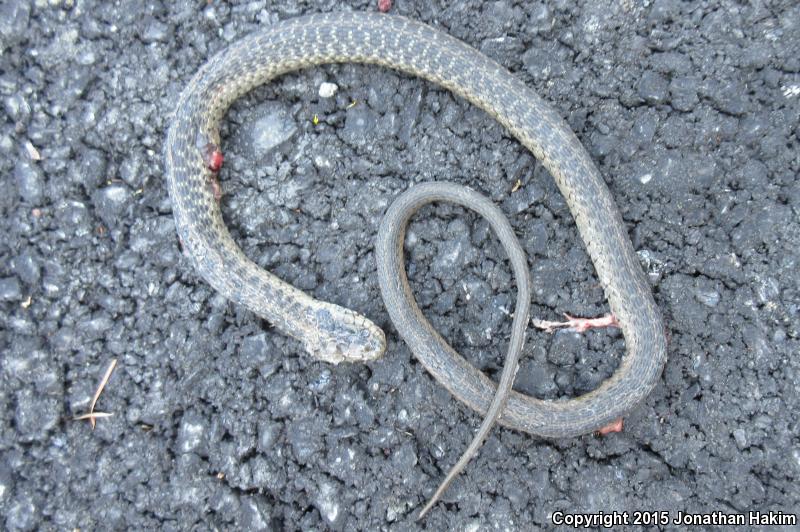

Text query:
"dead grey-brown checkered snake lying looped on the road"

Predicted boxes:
[[164, 12, 667, 514]]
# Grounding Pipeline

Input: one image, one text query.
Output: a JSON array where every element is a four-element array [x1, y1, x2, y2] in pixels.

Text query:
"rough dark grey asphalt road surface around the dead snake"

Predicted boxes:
[[0, 0, 800, 530]]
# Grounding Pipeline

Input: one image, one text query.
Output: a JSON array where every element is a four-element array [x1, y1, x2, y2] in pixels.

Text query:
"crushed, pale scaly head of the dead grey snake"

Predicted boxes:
[[305, 304, 386, 364]]
